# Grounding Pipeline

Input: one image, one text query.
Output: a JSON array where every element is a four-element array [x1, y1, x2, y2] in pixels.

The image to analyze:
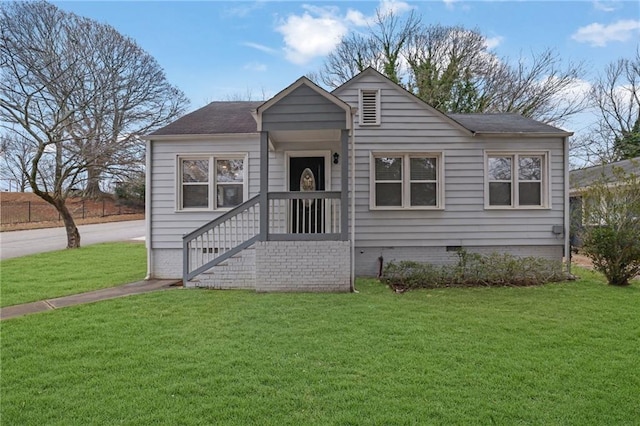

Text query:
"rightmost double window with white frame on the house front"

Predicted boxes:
[[485, 152, 548, 208]]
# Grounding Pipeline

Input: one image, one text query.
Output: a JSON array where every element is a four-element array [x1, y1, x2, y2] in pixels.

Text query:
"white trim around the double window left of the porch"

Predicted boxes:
[[175, 152, 249, 213]]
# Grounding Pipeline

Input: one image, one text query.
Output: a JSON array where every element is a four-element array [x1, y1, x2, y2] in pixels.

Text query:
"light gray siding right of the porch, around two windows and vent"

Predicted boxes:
[[334, 74, 564, 248]]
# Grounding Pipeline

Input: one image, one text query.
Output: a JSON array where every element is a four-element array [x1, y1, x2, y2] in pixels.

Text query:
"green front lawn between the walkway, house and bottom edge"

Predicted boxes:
[[0, 270, 640, 425]]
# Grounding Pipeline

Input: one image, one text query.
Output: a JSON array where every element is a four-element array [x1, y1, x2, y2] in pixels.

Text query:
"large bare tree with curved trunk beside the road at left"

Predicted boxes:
[[0, 2, 187, 248]]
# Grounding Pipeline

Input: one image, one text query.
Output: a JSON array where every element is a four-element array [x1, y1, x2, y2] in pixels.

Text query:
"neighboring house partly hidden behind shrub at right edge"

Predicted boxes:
[[569, 157, 640, 243]]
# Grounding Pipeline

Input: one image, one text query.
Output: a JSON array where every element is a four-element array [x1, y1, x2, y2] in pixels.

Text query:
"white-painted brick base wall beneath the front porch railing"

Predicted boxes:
[[256, 241, 351, 292]]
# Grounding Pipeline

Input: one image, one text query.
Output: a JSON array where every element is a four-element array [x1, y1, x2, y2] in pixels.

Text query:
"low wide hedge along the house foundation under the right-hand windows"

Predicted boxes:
[[380, 250, 570, 292]]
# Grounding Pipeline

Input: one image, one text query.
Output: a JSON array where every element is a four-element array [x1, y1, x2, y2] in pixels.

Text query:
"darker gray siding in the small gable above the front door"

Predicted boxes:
[[262, 85, 346, 131]]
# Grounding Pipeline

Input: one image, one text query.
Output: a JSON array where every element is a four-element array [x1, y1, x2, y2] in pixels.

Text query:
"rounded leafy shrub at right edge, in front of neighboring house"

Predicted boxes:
[[582, 164, 640, 286]]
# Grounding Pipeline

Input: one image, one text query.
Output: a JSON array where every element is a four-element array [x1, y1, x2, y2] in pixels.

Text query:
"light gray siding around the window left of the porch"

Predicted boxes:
[[147, 135, 260, 249]]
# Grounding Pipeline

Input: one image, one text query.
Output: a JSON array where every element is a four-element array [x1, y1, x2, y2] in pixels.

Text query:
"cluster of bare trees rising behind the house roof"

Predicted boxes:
[[320, 9, 586, 125]]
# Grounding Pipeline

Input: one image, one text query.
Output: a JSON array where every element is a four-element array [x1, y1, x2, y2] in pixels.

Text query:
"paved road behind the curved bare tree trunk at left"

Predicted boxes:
[[0, 220, 145, 259]]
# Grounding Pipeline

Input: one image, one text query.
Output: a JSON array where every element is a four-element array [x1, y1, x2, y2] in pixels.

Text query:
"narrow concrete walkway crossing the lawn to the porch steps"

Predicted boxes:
[[0, 280, 182, 320]]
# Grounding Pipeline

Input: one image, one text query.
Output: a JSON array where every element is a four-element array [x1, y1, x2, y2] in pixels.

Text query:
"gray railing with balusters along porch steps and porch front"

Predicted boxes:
[[182, 191, 344, 283]]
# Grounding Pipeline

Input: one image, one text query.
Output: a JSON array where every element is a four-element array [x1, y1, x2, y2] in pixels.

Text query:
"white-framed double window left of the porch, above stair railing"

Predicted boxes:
[[178, 155, 246, 210]]
